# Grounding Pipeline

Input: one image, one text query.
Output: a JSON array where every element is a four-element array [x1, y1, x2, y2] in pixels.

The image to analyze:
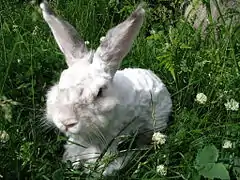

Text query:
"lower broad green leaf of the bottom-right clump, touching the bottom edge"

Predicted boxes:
[[199, 163, 230, 180]]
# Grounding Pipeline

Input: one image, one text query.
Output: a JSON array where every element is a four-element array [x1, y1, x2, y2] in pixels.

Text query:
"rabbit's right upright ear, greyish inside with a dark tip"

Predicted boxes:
[[93, 5, 145, 75]]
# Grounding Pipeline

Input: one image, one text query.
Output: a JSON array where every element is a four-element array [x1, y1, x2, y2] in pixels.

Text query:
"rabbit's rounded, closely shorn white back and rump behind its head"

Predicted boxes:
[[113, 68, 172, 129]]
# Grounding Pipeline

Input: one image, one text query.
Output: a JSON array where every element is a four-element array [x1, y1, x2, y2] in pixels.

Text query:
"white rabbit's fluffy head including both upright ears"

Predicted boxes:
[[40, 2, 145, 133]]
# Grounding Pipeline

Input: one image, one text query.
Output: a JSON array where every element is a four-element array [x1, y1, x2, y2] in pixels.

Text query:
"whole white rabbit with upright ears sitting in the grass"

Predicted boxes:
[[40, 2, 172, 175]]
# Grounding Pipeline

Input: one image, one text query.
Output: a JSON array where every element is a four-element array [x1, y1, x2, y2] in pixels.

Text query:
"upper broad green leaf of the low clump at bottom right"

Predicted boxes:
[[196, 145, 218, 165]]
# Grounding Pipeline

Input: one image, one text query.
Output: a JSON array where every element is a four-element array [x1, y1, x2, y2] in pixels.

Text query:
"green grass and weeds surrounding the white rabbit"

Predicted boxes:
[[0, 0, 240, 179]]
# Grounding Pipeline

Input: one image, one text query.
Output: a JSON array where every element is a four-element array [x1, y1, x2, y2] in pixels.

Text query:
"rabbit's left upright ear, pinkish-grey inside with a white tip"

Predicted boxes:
[[40, 1, 89, 66]]
